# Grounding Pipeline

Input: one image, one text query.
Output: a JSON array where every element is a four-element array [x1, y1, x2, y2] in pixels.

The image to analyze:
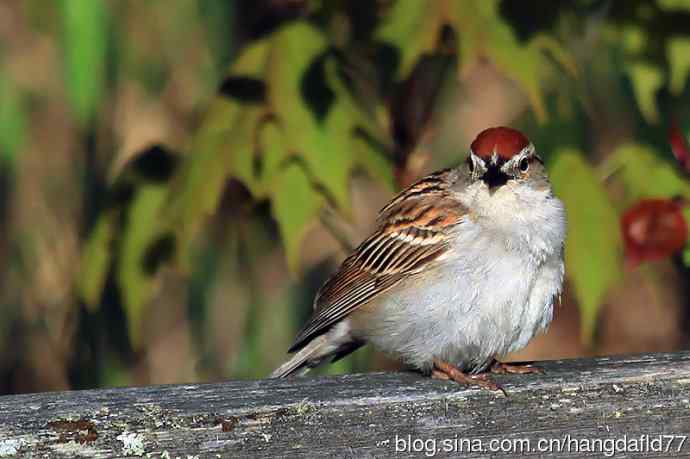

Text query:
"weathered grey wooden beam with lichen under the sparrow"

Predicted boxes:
[[0, 352, 690, 458]]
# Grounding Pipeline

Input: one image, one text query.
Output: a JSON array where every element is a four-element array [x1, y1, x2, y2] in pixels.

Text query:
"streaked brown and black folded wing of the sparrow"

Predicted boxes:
[[290, 170, 465, 352]]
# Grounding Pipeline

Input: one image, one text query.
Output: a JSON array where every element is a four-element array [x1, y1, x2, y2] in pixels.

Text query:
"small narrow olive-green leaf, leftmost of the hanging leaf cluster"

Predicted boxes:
[[78, 212, 117, 311]]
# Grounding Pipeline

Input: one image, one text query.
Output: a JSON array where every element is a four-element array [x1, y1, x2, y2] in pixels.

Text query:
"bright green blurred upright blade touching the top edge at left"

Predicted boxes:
[[62, 0, 108, 125]]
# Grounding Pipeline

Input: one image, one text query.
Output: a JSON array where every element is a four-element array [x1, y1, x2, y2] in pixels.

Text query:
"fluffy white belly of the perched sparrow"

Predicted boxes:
[[353, 220, 563, 371]]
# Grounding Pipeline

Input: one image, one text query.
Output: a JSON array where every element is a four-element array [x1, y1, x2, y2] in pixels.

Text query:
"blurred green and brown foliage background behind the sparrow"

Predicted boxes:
[[0, 0, 690, 393]]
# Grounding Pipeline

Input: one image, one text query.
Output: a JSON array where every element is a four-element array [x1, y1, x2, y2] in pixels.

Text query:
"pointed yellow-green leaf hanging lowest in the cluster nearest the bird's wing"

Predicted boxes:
[[271, 161, 323, 273]]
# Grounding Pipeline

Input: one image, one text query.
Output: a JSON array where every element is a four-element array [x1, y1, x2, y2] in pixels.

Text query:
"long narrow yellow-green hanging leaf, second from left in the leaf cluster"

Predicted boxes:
[[116, 184, 167, 349]]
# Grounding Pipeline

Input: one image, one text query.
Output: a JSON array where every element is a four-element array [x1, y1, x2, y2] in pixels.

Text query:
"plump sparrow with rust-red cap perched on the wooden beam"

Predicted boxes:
[[271, 127, 566, 390]]
